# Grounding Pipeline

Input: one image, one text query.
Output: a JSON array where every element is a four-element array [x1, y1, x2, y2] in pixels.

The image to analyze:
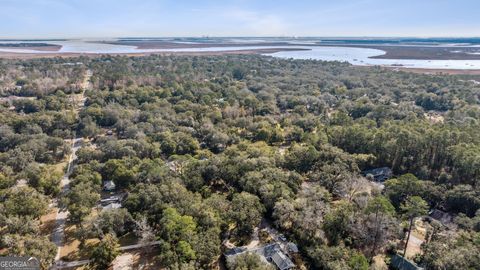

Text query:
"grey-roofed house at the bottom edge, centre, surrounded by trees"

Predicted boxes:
[[224, 243, 295, 270]]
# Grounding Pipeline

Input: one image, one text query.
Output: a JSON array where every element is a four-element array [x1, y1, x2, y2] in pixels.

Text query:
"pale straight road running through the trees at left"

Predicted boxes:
[[52, 70, 92, 262]]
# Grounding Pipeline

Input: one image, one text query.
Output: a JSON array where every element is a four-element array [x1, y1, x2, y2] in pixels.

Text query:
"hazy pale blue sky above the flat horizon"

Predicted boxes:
[[0, 0, 480, 38]]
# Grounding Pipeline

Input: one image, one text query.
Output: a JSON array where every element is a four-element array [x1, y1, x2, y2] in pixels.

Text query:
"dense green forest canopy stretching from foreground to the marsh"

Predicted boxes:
[[0, 55, 480, 269]]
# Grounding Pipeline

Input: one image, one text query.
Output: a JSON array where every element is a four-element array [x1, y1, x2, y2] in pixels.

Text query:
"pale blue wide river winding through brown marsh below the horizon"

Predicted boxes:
[[0, 40, 480, 69]]
